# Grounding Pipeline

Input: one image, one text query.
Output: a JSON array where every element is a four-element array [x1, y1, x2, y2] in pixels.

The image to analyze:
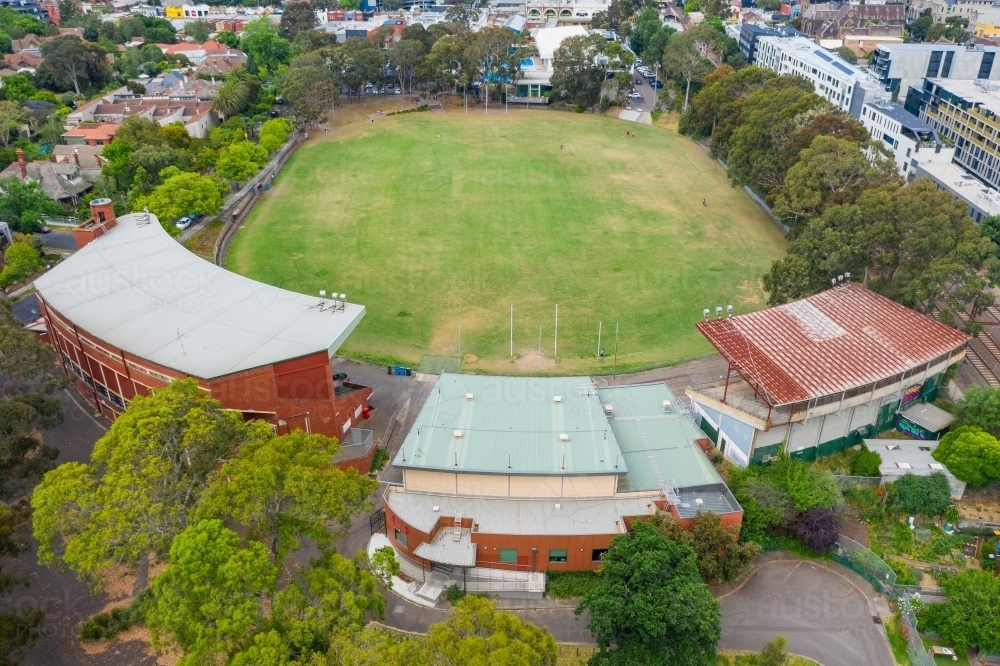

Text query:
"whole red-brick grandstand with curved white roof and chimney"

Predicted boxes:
[[35, 199, 374, 472]]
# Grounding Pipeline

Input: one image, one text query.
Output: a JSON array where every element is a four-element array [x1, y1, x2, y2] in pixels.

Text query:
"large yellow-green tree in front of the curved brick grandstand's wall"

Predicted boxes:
[[31, 380, 271, 587]]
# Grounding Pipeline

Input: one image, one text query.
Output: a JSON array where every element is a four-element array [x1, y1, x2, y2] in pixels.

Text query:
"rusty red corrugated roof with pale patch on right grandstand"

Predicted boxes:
[[697, 283, 969, 405]]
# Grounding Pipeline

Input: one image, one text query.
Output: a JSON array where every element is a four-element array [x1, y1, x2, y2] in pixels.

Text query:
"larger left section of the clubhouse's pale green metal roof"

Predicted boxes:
[[393, 374, 628, 476]]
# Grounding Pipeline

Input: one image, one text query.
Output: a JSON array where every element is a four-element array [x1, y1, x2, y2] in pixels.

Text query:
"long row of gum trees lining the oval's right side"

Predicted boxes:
[[682, 66, 1000, 314]]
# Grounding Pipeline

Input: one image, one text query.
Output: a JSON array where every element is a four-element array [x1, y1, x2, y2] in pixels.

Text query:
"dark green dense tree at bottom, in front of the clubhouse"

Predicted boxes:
[[577, 522, 722, 666]]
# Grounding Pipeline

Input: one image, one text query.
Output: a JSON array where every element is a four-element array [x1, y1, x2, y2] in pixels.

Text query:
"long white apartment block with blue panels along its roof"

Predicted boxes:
[[754, 37, 882, 118]]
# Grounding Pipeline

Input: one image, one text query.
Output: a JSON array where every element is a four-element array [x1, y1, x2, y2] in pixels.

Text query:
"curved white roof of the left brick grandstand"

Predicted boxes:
[[35, 213, 365, 379]]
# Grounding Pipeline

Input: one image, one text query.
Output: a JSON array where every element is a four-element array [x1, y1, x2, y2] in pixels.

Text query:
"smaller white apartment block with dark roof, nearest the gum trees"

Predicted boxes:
[[859, 99, 955, 176]]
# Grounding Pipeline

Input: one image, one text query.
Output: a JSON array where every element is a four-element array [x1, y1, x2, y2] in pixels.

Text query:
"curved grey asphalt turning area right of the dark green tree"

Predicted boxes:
[[719, 560, 896, 666]]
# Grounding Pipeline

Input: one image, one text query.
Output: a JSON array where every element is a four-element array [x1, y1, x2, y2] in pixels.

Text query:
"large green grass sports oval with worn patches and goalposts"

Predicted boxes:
[[227, 109, 785, 374]]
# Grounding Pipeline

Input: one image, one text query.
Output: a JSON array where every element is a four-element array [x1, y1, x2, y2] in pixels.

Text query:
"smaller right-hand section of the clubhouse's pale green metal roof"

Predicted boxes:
[[599, 383, 722, 492]]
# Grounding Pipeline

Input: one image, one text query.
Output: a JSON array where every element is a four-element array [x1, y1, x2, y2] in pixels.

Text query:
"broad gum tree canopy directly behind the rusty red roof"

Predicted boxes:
[[764, 179, 1000, 314]]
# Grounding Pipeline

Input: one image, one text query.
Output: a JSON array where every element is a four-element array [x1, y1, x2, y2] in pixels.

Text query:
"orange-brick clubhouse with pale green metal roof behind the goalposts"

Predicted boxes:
[[384, 374, 743, 592]]
